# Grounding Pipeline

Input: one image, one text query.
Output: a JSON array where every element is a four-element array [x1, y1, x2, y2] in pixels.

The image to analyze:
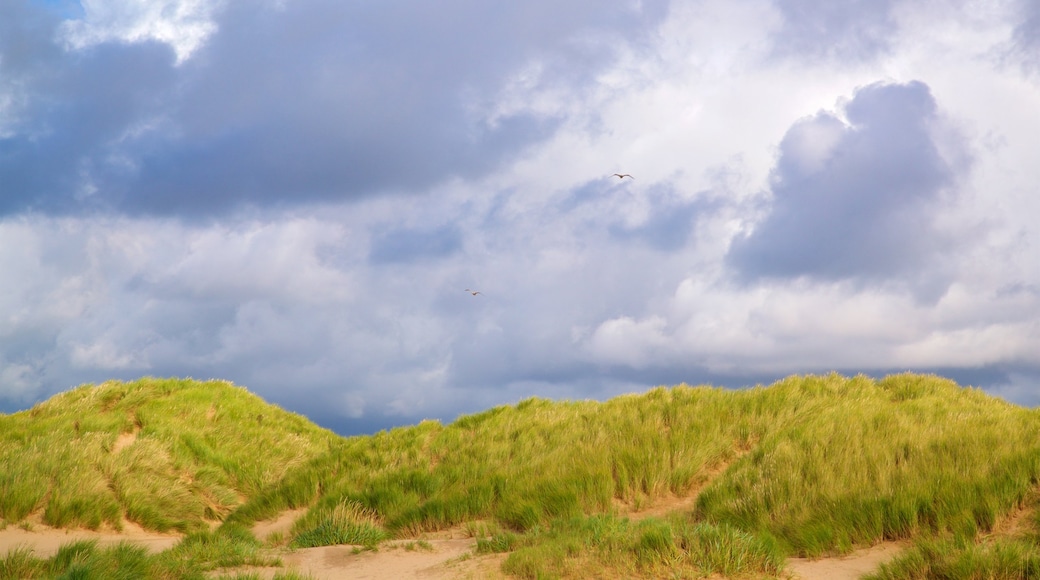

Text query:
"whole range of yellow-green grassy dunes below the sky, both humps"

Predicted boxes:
[[0, 374, 1040, 579]]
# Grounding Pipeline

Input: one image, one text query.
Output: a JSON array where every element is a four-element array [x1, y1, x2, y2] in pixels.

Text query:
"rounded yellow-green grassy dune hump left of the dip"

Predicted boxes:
[[0, 378, 338, 532]]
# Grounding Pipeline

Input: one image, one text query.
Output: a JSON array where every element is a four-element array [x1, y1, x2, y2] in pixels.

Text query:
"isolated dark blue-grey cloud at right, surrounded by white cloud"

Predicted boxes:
[[728, 82, 957, 288]]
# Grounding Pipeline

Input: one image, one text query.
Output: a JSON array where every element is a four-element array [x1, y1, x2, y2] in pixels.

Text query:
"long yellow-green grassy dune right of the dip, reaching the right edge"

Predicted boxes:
[[231, 374, 1040, 578]]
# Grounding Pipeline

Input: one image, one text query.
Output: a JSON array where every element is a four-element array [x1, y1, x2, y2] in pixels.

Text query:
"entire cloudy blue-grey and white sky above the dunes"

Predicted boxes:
[[0, 0, 1040, 434]]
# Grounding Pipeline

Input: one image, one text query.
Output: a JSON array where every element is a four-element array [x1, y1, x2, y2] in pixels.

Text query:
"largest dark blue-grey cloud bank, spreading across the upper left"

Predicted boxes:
[[0, 0, 666, 214]]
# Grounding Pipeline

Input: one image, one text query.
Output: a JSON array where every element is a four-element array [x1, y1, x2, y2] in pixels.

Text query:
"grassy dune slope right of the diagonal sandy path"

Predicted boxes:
[[696, 375, 1040, 556]]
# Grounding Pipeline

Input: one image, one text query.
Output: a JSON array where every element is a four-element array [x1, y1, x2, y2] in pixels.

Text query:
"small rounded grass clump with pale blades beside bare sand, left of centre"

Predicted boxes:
[[290, 501, 387, 548]]
